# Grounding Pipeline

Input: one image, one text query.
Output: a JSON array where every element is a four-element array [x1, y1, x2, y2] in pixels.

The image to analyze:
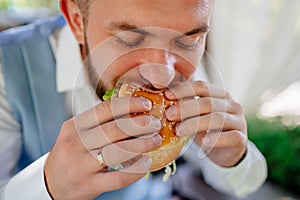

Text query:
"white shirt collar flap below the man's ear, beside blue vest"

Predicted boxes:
[[50, 25, 88, 92]]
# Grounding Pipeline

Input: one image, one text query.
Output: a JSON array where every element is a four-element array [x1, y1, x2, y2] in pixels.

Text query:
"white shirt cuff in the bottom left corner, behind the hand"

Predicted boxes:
[[4, 154, 51, 200]]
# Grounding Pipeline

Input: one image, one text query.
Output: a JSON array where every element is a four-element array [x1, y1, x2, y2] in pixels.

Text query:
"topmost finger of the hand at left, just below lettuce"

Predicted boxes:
[[75, 97, 152, 130]]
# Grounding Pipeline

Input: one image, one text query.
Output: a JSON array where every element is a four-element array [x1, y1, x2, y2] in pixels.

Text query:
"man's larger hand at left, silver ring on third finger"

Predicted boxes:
[[44, 97, 162, 199]]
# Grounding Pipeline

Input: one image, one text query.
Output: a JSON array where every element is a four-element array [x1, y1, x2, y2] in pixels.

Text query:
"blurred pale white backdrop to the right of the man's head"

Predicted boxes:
[[207, 0, 300, 120]]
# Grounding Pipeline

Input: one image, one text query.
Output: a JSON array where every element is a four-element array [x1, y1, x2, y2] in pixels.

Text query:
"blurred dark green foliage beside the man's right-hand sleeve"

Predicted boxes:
[[248, 117, 300, 193]]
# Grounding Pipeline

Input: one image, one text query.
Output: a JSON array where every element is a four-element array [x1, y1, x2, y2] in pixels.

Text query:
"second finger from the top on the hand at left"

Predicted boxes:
[[80, 116, 161, 150]]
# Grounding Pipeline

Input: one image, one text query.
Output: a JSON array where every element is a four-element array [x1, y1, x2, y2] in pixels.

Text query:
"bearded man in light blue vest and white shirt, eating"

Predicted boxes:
[[0, 0, 266, 199]]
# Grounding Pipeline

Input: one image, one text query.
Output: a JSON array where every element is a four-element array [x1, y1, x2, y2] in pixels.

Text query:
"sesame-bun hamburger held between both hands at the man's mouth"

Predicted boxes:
[[116, 83, 186, 174]]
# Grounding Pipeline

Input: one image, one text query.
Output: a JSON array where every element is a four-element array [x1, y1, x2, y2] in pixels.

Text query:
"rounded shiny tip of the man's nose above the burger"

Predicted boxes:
[[139, 63, 175, 89]]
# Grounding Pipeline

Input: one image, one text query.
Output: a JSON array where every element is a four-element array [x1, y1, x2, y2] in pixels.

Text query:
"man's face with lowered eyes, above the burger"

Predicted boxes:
[[80, 0, 212, 97]]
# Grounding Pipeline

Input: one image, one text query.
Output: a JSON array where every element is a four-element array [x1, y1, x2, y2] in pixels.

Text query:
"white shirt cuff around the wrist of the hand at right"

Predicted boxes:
[[201, 141, 267, 198]]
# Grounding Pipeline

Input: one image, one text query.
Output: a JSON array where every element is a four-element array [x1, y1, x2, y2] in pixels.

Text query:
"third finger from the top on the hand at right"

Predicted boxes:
[[176, 112, 245, 136]]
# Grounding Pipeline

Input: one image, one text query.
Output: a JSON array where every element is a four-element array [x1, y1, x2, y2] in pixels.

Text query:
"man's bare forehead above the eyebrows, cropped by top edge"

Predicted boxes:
[[89, 0, 212, 32]]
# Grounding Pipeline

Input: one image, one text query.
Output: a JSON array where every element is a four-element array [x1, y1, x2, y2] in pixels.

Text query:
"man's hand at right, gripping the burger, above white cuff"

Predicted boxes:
[[165, 81, 247, 167]]
